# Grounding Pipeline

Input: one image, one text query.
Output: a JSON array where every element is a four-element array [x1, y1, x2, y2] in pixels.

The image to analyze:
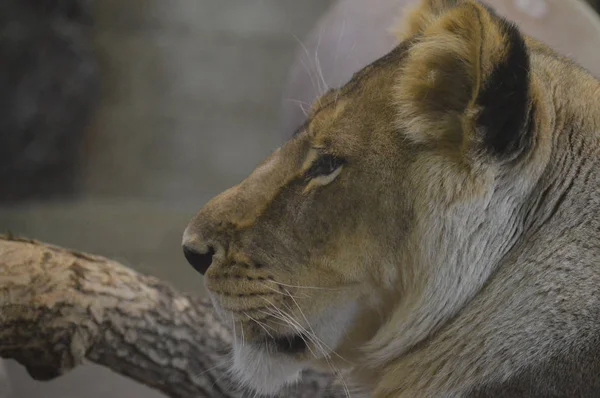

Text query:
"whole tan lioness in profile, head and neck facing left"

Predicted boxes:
[[183, 0, 600, 398]]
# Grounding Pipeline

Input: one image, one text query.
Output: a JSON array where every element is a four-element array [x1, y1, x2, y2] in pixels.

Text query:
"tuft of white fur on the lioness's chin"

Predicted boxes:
[[231, 342, 304, 395]]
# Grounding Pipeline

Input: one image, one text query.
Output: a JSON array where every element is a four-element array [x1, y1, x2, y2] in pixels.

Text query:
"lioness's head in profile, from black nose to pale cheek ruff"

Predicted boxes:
[[183, 0, 597, 394]]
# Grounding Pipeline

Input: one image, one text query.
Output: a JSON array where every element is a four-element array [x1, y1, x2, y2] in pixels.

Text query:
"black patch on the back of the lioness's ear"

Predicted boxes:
[[476, 17, 532, 157]]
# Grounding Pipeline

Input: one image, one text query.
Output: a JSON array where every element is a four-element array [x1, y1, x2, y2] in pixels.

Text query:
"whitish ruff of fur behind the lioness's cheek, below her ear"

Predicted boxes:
[[369, 188, 523, 363]]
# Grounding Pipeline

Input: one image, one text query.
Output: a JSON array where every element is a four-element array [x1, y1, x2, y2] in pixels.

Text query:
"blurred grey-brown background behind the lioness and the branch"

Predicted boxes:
[[0, 0, 600, 398]]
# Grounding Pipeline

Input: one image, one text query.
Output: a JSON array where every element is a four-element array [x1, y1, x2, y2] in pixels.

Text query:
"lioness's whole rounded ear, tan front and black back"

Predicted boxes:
[[396, 0, 531, 159]]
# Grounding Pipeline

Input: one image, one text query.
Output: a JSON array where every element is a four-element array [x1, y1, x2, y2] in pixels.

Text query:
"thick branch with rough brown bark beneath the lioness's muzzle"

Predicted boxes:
[[0, 237, 341, 398]]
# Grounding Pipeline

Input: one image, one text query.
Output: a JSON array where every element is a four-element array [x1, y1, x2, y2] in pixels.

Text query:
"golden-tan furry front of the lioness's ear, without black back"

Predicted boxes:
[[397, 2, 506, 150]]
